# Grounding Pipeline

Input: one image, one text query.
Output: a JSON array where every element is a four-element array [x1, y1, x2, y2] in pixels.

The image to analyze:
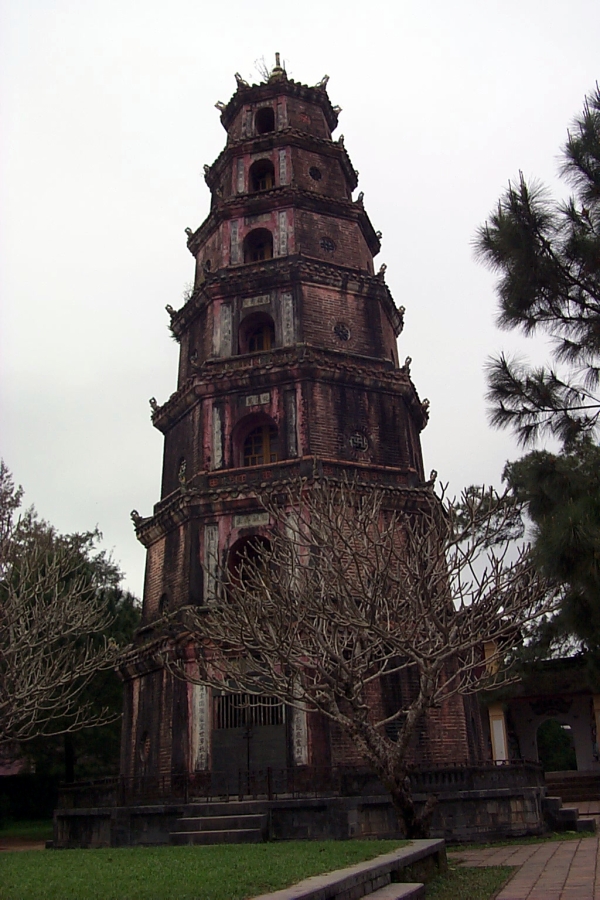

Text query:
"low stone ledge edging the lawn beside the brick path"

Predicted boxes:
[[248, 840, 446, 900]]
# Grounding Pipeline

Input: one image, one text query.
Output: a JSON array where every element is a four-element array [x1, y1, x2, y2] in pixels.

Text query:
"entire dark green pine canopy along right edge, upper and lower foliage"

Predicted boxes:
[[476, 86, 600, 662]]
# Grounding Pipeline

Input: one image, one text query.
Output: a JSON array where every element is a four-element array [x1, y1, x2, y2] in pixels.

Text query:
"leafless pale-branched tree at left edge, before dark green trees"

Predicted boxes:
[[0, 462, 118, 746]]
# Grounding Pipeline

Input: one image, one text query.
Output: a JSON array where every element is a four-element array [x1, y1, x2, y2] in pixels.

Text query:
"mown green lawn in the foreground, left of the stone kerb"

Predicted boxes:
[[0, 841, 406, 900]]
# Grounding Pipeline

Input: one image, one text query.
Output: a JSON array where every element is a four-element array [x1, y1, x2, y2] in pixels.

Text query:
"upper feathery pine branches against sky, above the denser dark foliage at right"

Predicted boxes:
[[476, 87, 600, 446]]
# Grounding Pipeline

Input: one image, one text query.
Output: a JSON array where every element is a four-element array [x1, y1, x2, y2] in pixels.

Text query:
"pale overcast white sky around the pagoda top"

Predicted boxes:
[[0, 0, 600, 596]]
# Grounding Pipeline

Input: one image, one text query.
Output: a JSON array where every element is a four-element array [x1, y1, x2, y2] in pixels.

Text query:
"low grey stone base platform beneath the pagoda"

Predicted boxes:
[[54, 786, 546, 848]]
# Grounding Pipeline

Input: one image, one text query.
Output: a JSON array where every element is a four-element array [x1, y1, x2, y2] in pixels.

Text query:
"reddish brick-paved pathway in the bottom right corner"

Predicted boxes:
[[448, 837, 600, 900]]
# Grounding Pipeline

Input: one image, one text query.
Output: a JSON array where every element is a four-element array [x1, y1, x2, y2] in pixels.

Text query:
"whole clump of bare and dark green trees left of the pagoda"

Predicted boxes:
[[0, 462, 139, 777]]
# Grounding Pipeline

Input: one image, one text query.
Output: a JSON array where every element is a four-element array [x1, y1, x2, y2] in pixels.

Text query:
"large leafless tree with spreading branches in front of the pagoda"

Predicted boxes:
[[164, 479, 555, 837]]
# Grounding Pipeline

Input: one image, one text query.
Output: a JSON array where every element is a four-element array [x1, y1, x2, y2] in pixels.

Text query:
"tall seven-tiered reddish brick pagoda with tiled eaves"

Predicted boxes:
[[122, 61, 481, 788]]
